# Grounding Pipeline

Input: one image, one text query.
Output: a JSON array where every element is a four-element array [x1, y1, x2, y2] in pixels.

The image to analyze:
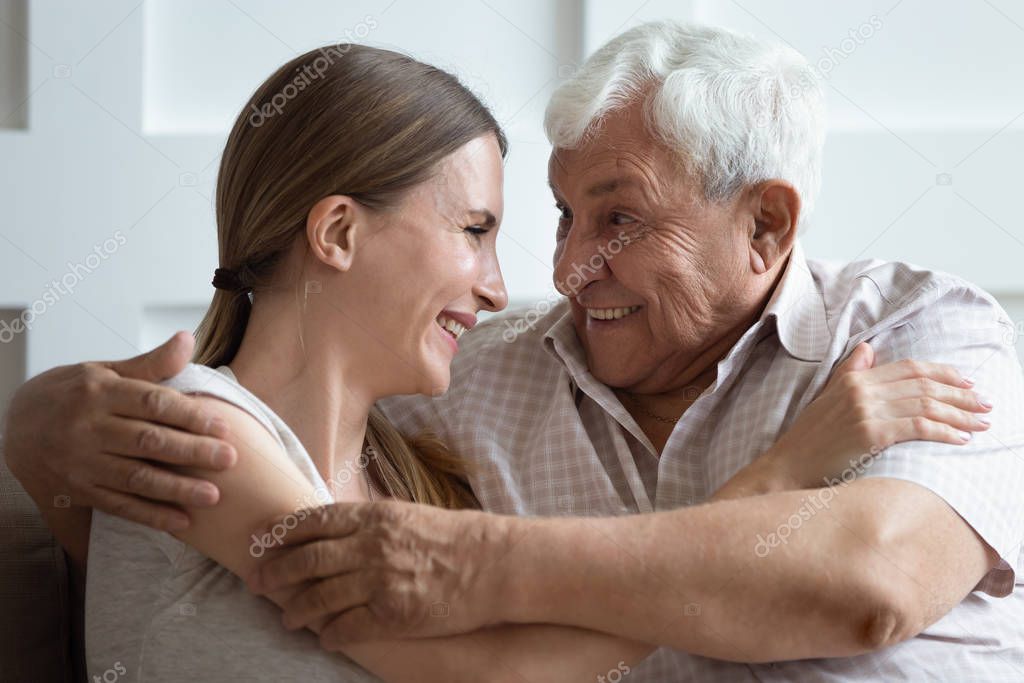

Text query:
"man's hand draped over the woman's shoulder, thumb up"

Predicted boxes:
[[4, 332, 237, 542]]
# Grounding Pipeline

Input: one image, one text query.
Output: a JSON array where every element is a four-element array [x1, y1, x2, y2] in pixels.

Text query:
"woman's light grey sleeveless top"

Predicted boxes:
[[85, 365, 378, 683]]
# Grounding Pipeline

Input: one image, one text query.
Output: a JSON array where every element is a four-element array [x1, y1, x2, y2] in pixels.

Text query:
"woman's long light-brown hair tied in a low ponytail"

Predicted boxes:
[[195, 44, 508, 508]]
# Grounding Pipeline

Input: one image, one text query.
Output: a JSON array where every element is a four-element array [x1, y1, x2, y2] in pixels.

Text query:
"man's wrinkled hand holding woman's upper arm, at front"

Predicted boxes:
[[248, 502, 507, 650]]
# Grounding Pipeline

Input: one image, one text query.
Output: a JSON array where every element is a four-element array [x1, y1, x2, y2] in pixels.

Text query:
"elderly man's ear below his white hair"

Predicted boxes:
[[750, 180, 800, 274]]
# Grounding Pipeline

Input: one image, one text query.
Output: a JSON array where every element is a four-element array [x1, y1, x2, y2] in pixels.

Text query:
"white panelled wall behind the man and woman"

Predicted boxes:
[[0, 0, 1024, 399]]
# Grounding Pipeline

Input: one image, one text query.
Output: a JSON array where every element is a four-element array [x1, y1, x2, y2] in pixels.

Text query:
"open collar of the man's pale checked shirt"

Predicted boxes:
[[544, 241, 831, 370]]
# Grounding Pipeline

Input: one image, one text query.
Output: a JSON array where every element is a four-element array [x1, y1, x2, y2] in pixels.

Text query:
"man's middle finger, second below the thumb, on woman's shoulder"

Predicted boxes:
[[94, 416, 238, 470]]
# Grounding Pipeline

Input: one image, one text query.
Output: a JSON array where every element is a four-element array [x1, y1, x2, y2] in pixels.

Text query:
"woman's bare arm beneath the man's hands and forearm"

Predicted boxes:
[[175, 396, 653, 682]]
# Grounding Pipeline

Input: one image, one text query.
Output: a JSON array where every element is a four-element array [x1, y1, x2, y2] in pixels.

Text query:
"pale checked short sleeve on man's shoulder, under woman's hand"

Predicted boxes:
[[863, 286, 1024, 597]]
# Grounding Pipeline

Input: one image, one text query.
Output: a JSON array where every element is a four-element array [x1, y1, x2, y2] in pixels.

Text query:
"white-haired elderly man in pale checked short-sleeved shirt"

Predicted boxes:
[[8, 22, 1024, 681]]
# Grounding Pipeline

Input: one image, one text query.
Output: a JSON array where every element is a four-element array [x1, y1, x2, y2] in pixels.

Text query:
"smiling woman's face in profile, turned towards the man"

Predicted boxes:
[[339, 135, 508, 395]]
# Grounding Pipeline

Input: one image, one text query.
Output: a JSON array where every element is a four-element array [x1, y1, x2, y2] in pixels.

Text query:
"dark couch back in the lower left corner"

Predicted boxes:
[[0, 454, 85, 683]]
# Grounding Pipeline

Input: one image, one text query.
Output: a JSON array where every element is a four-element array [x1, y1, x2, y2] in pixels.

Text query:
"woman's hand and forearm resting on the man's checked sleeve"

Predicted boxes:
[[714, 342, 992, 500]]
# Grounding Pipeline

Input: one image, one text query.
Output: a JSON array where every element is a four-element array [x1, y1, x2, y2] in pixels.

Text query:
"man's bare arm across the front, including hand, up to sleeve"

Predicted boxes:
[[249, 479, 995, 663]]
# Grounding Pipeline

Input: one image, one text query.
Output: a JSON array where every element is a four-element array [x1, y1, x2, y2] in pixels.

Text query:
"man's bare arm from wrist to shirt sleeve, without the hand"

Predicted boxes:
[[491, 480, 985, 661]]
